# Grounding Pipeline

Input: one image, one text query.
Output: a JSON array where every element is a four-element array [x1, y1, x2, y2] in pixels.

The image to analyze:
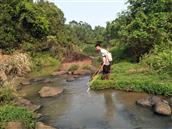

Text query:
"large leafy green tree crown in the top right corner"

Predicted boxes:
[[106, 0, 172, 61]]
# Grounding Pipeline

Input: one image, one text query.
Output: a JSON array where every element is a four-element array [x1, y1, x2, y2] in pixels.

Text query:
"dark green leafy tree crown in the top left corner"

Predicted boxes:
[[0, 0, 49, 50]]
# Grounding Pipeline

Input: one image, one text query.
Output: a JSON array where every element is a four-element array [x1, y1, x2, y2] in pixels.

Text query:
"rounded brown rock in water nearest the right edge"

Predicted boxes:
[[154, 102, 171, 116]]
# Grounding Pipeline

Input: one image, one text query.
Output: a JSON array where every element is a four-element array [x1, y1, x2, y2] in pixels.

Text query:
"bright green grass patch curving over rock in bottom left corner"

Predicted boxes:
[[0, 105, 35, 129]]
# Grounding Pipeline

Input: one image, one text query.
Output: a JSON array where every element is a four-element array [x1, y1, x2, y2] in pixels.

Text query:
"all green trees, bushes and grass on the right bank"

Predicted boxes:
[[91, 0, 172, 95]]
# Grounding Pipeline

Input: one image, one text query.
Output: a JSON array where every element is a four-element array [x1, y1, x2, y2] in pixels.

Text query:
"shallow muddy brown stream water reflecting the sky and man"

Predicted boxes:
[[22, 76, 172, 129]]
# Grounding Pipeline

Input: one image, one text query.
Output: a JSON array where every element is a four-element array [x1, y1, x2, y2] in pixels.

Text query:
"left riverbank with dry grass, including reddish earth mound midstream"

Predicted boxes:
[[0, 53, 93, 129]]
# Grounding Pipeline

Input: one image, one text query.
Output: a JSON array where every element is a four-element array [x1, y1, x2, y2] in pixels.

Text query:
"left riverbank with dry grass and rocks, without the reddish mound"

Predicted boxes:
[[0, 52, 60, 129]]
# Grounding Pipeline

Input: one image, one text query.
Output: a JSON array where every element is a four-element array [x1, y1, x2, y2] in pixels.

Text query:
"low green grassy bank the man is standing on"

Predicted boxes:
[[90, 62, 172, 96]]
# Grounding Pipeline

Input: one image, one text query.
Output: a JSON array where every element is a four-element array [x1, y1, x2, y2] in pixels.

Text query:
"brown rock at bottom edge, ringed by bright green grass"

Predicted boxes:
[[5, 122, 26, 129]]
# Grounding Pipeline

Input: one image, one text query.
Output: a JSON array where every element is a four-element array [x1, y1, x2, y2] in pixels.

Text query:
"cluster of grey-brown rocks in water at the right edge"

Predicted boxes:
[[136, 96, 172, 116]]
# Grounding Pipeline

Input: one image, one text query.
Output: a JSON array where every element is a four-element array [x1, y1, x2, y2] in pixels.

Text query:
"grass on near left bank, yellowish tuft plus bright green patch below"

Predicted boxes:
[[0, 84, 36, 129]]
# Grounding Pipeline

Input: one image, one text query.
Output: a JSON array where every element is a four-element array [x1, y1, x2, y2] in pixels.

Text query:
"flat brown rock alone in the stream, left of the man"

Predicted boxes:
[[39, 86, 64, 97]]
